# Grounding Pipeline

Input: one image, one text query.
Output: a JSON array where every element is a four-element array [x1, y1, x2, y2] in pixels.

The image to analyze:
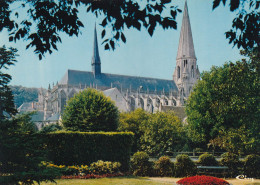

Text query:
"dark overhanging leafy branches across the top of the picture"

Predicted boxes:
[[0, 0, 260, 59]]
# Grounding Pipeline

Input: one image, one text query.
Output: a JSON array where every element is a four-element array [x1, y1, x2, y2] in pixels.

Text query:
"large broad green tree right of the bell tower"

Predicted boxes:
[[186, 50, 260, 152]]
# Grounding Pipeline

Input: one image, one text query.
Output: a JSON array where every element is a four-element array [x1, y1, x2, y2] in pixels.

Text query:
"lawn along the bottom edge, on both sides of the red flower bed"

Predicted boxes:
[[41, 177, 260, 185]]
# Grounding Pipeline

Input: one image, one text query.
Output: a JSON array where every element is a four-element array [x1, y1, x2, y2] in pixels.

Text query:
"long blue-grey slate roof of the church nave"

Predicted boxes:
[[59, 69, 177, 93]]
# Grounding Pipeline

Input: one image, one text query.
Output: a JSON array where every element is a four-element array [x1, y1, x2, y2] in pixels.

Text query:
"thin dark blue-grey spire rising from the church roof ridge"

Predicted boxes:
[[91, 24, 101, 77]]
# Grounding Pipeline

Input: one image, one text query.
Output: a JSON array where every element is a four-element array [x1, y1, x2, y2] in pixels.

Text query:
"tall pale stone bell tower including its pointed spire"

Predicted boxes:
[[173, 1, 200, 105]]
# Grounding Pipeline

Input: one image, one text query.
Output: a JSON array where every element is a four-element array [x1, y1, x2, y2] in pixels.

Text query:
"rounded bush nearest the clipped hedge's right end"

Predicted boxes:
[[131, 152, 152, 176]]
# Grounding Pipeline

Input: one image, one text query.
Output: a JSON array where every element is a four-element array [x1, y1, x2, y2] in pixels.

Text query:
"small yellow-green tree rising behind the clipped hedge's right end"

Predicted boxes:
[[118, 108, 151, 152]]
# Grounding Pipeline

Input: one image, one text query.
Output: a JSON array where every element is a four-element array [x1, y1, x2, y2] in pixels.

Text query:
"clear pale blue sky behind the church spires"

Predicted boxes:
[[0, 0, 244, 88]]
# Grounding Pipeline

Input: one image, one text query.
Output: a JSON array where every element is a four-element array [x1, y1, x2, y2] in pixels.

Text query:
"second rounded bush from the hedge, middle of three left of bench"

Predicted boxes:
[[155, 156, 174, 177]]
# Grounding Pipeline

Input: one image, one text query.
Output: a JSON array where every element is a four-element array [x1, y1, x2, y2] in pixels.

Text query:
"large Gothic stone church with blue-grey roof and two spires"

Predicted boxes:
[[20, 2, 200, 122]]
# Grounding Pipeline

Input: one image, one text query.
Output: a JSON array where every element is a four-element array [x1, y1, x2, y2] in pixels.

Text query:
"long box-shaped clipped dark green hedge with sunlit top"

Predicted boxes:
[[42, 131, 134, 170]]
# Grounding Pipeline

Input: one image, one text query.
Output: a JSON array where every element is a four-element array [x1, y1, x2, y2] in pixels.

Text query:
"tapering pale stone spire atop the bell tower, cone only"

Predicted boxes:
[[177, 1, 196, 59]]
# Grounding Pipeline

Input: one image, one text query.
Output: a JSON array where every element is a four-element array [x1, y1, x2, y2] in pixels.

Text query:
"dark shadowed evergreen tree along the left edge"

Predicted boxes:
[[0, 47, 59, 185]]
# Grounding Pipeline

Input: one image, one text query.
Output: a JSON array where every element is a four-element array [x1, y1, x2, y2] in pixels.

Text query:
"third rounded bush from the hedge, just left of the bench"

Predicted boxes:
[[174, 154, 197, 177]]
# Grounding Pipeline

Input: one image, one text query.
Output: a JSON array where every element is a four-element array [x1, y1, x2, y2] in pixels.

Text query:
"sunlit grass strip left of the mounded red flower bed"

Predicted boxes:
[[41, 177, 173, 185]]
